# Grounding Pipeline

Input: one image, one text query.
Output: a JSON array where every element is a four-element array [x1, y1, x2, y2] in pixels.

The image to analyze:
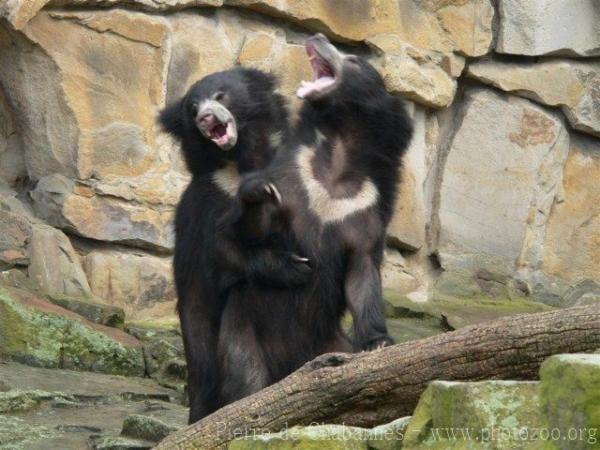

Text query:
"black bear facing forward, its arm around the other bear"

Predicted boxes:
[[160, 68, 310, 423]]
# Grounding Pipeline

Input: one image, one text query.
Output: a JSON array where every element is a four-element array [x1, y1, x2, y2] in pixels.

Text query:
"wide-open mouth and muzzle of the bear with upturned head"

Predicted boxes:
[[296, 34, 338, 99]]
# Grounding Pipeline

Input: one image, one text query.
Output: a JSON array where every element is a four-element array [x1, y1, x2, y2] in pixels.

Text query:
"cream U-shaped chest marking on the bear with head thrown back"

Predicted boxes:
[[296, 146, 379, 224]]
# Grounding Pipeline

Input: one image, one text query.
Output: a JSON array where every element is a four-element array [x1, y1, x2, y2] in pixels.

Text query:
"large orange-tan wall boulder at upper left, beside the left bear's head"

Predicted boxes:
[[0, 8, 169, 179]]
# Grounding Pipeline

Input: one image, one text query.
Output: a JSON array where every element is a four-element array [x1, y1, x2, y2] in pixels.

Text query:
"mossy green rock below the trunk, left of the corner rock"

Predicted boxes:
[[402, 381, 543, 450]]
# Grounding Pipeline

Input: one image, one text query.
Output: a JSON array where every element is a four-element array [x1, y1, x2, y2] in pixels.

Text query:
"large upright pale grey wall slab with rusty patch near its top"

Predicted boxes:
[[437, 90, 569, 292]]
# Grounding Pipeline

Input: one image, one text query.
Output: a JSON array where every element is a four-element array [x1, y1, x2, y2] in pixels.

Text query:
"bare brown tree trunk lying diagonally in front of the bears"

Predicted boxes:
[[157, 305, 600, 450]]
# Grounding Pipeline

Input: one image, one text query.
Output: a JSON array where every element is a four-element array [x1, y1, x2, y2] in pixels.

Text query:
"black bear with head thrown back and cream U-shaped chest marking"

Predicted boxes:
[[219, 34, 412, 402]]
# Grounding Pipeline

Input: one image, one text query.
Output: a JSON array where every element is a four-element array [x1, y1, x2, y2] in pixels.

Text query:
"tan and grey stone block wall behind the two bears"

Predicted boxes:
[[0, 0, 600, 320]]
